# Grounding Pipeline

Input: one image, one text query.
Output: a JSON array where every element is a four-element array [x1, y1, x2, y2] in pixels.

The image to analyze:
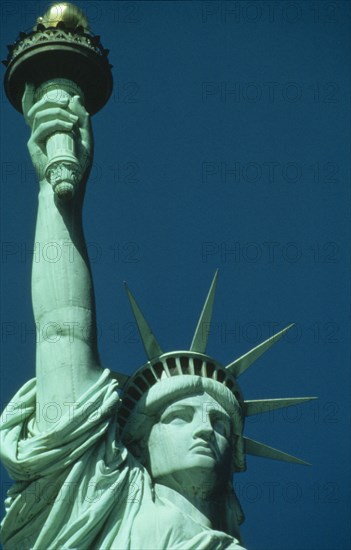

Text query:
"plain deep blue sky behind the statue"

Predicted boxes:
[[1, 0, 350, 550]]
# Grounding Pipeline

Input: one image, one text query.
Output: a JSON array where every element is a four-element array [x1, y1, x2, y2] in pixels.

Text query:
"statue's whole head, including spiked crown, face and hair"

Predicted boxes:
[[115, 273, 313, 534]]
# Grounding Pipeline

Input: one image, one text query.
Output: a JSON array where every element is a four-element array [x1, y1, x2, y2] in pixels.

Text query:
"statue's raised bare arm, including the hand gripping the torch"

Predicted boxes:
[[23, 88, 101, 430]]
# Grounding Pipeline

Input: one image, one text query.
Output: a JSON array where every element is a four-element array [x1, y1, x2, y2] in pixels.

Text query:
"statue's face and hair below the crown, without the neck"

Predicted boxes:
[[121, 374, 245, 489]]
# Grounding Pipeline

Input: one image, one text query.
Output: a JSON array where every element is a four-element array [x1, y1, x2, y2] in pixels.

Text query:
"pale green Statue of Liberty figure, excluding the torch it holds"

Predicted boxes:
[[1, 5, 316, 550]]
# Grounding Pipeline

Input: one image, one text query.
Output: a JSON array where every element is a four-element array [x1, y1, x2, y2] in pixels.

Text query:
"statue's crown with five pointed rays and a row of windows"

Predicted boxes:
[[114, 271, 315, 464]]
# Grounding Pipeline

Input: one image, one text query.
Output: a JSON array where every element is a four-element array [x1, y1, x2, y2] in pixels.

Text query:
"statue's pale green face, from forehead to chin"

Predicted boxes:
[[148, 393, 231, 492]]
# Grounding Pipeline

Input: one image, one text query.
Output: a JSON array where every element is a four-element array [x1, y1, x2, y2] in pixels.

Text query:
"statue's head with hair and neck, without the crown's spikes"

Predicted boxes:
[[120, 368, 245, 538]]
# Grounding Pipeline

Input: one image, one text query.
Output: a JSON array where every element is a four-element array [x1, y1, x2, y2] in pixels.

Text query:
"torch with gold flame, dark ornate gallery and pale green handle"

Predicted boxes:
[[3, 2, 113, 200]]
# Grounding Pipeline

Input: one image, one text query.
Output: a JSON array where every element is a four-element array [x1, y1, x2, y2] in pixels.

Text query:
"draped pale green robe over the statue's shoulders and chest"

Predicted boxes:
[[0, 369, 242, 550]]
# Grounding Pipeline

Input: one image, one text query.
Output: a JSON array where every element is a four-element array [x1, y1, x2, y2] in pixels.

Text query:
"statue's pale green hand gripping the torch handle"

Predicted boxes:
[[22, 84, 93, 194]]
